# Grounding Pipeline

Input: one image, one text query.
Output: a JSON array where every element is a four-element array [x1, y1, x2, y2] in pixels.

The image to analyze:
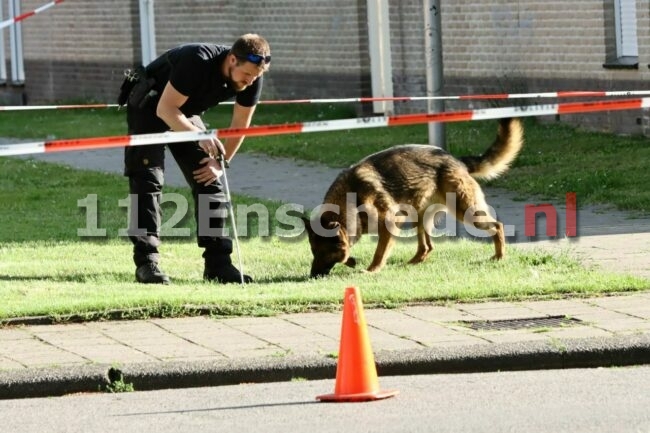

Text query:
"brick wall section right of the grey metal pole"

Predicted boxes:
[[442, 0, 650, 133]]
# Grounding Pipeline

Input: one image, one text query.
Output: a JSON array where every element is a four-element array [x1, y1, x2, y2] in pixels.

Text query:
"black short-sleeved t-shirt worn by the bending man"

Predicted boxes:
[[147, 44, 262, 116]]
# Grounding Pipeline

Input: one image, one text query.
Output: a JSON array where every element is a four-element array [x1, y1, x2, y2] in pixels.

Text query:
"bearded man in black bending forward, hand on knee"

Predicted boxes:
[[121, 34, 271, 284]]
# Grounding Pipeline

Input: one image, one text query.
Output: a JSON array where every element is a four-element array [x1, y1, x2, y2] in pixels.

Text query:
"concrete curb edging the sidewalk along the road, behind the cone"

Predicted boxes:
[[0, 334, 650, 399]]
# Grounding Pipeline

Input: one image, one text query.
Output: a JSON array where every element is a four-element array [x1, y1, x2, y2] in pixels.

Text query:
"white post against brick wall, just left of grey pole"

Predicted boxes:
[[367, 0, 393, 114]]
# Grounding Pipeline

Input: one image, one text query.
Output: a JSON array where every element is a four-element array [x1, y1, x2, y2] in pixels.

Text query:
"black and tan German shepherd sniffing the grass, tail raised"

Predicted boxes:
[[303, 119, 523, 277]]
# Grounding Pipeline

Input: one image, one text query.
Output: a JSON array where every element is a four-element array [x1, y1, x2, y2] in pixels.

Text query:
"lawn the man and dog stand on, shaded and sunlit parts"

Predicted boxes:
[[0, 158, 648, 321]]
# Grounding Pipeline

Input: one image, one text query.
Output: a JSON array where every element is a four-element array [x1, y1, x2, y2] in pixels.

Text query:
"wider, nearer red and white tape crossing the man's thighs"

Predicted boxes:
[[0, 98, 650, 156]]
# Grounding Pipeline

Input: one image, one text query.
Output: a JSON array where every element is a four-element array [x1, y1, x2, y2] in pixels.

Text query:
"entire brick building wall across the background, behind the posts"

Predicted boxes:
[[0, 0, 650, 132]]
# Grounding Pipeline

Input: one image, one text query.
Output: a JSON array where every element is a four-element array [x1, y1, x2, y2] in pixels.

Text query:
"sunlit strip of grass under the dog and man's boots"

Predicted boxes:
[[0, 224, 648, 320]]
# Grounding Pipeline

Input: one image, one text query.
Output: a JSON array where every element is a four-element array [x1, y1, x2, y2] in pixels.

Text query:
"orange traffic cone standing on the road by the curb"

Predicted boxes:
[[316, 287, 399, 402]]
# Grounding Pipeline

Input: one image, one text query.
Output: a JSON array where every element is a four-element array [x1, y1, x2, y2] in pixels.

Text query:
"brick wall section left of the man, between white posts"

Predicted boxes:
[[13, 0, 139, 103]]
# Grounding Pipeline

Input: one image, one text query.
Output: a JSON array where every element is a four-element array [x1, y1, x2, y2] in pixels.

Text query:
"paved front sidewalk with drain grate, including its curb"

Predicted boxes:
[[0, 288, 650, 399]]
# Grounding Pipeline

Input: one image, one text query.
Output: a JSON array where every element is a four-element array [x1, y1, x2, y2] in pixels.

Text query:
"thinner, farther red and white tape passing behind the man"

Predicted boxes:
[[0, 90, 650, 111]]
